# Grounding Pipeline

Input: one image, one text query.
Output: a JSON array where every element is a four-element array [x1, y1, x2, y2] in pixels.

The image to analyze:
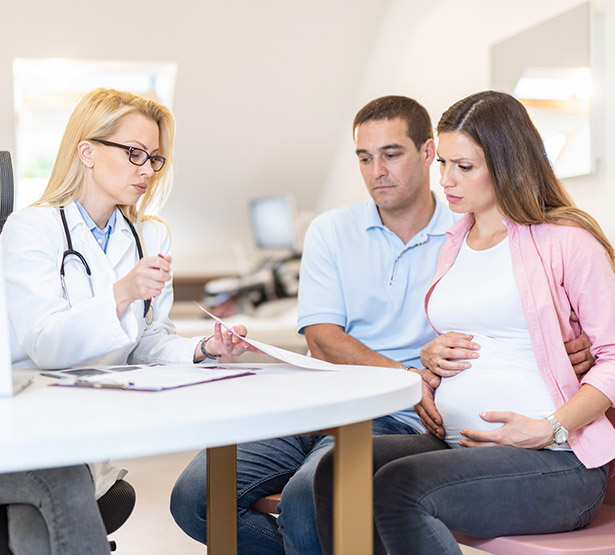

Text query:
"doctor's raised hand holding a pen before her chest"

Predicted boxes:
[[113, 254, 171, 317]]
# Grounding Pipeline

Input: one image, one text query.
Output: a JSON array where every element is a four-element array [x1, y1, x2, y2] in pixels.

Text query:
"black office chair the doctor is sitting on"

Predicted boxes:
[[0, 150, 136, 555]]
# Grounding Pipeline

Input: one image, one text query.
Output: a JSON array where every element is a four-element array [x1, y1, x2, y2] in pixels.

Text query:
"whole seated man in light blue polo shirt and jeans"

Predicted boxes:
[[171, 96, 454, 555]]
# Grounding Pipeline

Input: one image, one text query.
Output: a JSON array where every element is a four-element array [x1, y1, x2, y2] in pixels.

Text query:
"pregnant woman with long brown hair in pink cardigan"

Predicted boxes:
[[315, 91, 615, 555]]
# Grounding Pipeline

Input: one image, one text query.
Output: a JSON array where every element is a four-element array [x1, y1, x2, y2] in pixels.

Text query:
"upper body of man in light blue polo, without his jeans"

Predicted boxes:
[[298, 100, 455, 433]]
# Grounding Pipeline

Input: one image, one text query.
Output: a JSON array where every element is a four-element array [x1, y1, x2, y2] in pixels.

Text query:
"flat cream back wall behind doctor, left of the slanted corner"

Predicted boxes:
[[0, 0, 388, 273]]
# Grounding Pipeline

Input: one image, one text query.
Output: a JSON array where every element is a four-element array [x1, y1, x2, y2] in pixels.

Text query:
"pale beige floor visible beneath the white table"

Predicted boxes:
[[111, 451, 484, 555]]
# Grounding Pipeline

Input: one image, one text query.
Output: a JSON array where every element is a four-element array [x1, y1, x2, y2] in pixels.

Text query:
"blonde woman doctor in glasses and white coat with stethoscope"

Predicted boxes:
[[0, 89, 249, 555]]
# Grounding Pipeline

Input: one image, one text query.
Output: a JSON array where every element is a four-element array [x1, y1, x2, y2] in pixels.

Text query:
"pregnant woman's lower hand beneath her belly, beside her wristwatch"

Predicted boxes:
[[459, 411, 553, 449]]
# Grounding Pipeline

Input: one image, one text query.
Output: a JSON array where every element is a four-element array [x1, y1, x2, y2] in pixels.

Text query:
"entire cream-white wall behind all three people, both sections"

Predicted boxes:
[[0, 0, 615, 274]]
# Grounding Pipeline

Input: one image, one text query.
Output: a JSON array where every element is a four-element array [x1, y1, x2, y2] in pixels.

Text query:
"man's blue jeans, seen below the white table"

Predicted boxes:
[[171, 416, 414, 555]]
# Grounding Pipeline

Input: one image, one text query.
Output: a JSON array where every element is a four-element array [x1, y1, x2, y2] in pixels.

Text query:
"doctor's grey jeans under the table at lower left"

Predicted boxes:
[[0, 465, 110, 555]]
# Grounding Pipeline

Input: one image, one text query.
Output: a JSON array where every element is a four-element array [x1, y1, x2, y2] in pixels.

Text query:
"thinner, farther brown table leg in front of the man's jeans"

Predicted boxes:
[[207, 445, 237, 555]]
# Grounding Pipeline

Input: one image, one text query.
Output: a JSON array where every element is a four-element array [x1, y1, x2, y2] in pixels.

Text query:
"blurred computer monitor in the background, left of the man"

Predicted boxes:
[[250, 195, 296, 250]]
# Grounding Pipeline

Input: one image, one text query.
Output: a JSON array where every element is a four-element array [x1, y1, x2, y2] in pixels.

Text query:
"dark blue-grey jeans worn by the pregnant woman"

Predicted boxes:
[[314, 435, 608, 555]]
